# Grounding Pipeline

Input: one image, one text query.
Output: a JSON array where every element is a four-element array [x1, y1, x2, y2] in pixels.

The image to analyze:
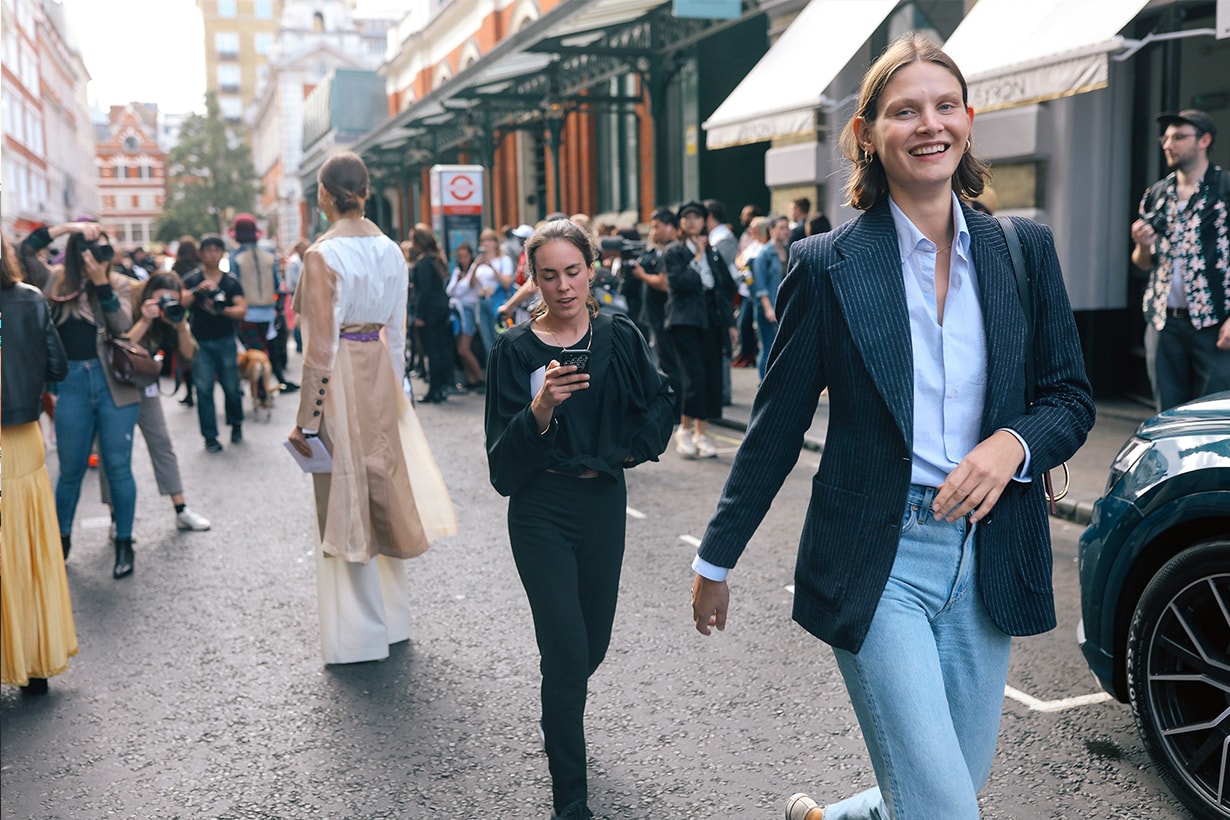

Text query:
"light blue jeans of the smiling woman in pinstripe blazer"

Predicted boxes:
[[824, 486, 1011, 820]]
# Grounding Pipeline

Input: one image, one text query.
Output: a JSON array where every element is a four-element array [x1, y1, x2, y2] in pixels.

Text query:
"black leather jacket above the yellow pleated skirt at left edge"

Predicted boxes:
[[0, 283, 69, 427]]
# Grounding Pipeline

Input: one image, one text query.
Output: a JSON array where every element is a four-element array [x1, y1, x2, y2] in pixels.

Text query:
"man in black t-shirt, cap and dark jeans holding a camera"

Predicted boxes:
[[183, 234, 247, 452]]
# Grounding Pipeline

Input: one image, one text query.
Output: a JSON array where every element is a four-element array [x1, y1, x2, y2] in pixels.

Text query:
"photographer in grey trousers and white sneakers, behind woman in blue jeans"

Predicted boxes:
[[98, 273, 209, 531]]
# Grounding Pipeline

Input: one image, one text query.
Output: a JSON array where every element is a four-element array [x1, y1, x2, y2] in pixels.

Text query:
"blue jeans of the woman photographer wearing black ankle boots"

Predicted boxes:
[[55, 359, 141, 538]]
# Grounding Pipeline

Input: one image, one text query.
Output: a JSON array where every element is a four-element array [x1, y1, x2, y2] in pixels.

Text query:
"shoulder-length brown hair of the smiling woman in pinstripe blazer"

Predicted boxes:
[[839, 32, 990, 210]]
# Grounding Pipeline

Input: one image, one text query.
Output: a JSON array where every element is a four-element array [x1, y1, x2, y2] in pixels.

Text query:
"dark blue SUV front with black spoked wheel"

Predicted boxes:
[[1077, 392, 1230, 818]]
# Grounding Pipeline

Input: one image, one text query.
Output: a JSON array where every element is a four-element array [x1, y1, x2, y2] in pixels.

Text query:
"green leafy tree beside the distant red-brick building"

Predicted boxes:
[[154, 92, 263, 242]]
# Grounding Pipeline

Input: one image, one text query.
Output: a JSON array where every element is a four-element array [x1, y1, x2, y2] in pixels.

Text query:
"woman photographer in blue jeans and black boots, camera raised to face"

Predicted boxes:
[[43, 221, 141, 578]]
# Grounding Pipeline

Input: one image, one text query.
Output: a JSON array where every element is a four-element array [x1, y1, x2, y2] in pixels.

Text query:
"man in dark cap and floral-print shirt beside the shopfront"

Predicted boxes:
[[1132, 108, 1230, 411]]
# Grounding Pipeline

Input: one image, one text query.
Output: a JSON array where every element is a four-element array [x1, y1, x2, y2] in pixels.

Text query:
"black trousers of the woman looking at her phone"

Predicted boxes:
[[508, 472, 627, 811]]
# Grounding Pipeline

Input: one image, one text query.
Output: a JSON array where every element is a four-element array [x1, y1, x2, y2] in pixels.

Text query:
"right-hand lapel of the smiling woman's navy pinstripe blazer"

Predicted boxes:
[[966, 209, 1026, 438]]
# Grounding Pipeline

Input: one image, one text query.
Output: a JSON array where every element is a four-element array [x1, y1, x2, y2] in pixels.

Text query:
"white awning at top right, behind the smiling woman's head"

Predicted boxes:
[[943, 0, 1149, 111]]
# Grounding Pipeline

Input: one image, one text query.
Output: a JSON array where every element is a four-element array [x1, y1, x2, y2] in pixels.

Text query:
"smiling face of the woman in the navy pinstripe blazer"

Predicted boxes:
[[856, 61, 974, 198]]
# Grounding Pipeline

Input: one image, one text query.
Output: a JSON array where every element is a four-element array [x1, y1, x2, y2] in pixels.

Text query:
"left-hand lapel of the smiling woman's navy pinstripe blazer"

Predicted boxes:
[[830, 200, 914, 446]]
